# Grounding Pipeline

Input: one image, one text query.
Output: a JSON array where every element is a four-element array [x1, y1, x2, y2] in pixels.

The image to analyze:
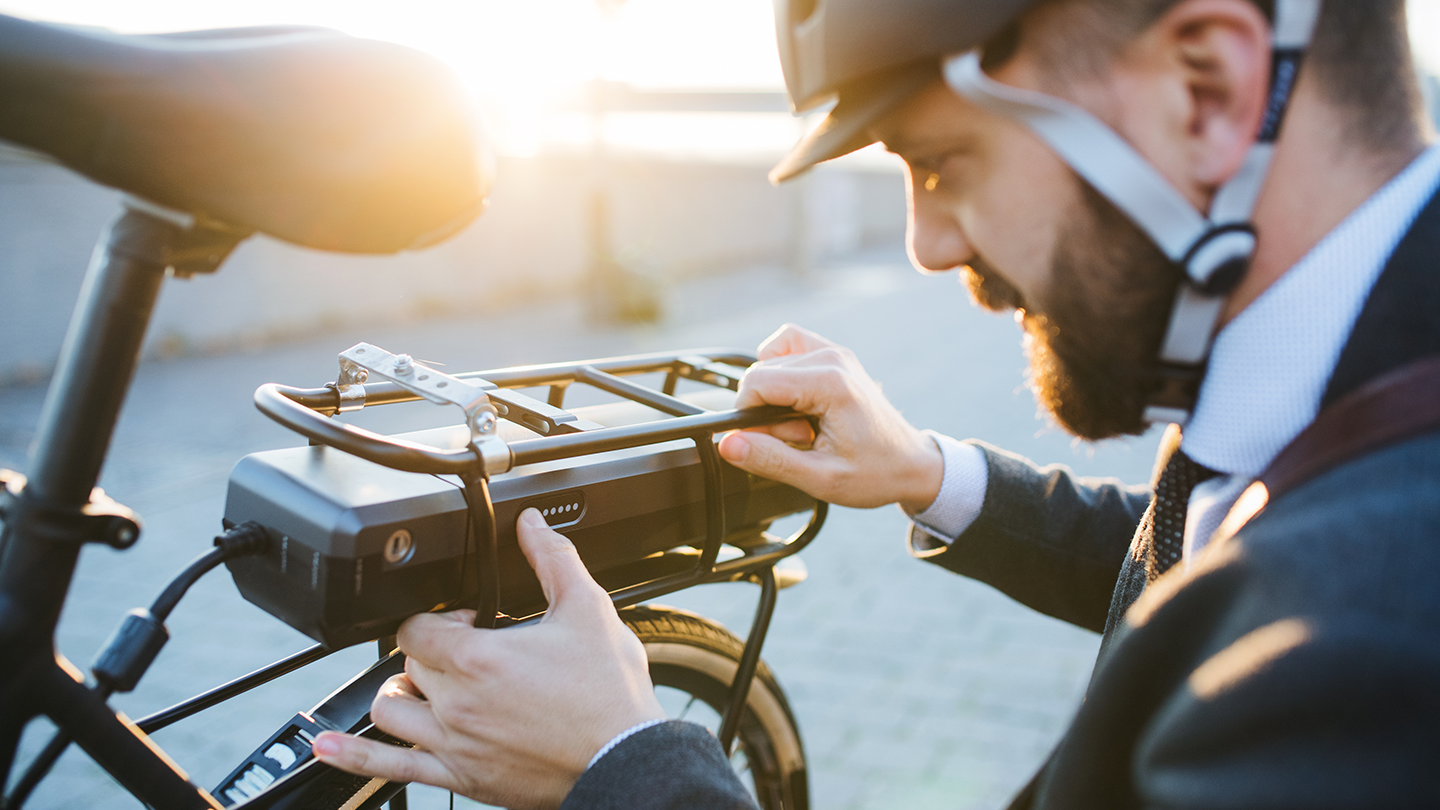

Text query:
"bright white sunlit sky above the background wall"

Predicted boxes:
[[0, 0, 1440, 160]]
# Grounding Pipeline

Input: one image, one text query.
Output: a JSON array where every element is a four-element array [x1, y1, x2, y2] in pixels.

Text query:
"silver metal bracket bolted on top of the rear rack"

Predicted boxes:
[[336, 343, 514, 476]]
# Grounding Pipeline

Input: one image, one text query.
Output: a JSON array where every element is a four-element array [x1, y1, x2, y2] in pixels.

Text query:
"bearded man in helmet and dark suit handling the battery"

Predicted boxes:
[[315, 0, 1440, 809]]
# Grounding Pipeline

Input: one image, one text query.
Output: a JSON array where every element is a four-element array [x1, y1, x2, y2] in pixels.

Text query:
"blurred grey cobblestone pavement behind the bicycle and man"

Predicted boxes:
[[0, 242, 1156, 810]]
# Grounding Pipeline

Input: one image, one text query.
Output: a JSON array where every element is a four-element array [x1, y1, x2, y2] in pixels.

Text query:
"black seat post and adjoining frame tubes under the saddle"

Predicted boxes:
[[0, 209, 243, 807]]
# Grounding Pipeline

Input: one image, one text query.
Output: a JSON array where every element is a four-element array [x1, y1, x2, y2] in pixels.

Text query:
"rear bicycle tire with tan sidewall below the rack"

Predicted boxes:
[[619, 605, 809, 810]]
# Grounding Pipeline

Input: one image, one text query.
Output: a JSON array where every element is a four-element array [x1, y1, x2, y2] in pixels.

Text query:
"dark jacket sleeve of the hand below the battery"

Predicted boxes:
[[560, 721, 755, 810]]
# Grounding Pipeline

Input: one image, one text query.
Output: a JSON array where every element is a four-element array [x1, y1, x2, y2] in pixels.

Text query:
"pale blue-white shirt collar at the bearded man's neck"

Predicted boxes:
[[1182, 146, 1440, 479]]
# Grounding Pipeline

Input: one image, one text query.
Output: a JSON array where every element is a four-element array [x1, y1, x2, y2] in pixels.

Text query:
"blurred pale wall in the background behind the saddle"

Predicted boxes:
[[0, 147, 904, 385]]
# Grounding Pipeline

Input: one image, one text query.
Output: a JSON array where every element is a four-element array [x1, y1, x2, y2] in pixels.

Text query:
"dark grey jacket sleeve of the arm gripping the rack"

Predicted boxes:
[[910, 441, 1151, 633]]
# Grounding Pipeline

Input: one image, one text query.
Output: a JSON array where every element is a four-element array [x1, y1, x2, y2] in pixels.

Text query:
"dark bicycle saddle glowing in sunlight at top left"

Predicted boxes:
[[0, 16, 492, 254]]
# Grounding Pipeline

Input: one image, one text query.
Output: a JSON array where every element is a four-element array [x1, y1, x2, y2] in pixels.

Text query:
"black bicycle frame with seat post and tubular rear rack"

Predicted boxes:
[[0, 203, 825, 810]]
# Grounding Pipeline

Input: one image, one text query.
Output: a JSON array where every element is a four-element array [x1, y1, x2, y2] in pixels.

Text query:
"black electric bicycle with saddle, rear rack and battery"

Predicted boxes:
[[0, 17, 825, 810]]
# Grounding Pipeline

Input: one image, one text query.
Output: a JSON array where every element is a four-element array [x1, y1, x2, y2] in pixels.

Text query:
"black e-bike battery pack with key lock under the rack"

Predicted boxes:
[[225, 404, 815, 647]]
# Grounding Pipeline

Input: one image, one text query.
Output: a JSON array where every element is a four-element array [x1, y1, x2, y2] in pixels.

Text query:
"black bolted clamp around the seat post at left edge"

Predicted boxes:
[[0, 470, 141, 549]]
